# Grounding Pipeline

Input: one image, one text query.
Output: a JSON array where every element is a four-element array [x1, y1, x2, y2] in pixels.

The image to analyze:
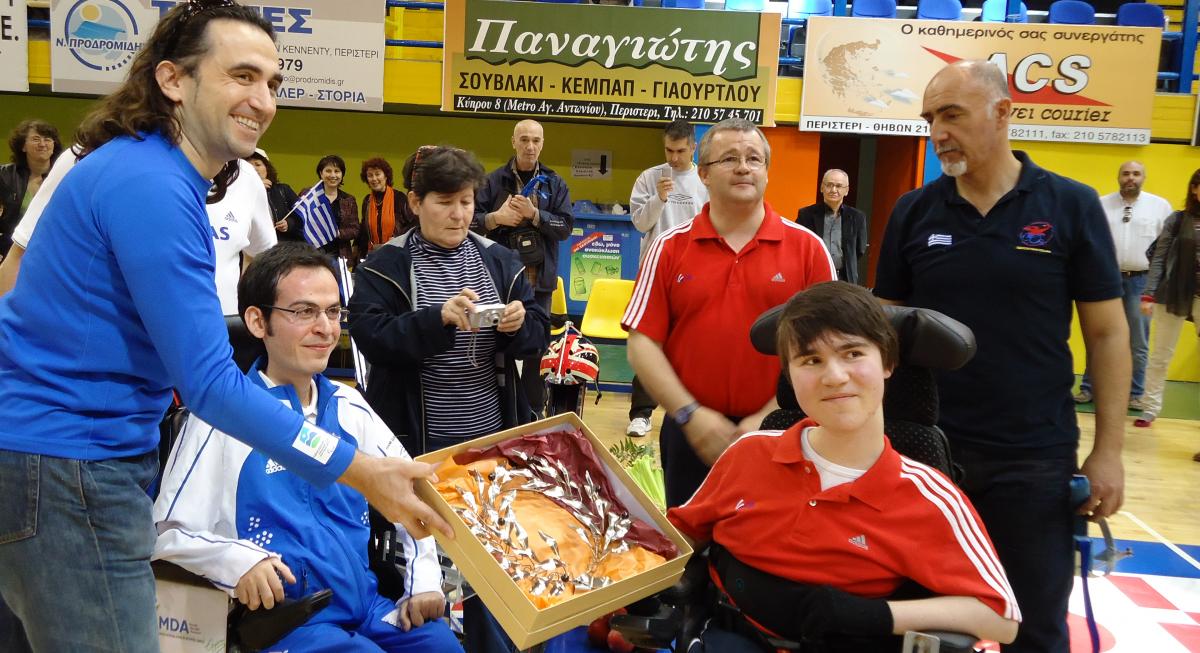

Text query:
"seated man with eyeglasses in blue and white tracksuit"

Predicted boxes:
[[154, 242, 462, 652]]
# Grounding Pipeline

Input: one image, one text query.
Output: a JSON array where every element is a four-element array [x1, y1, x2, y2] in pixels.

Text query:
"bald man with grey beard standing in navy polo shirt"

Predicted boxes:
[[875, 61, 1129, 653]]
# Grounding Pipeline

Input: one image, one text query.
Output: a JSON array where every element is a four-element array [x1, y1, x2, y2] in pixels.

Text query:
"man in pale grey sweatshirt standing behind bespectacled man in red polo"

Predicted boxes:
[[625, 119, 708, 437]]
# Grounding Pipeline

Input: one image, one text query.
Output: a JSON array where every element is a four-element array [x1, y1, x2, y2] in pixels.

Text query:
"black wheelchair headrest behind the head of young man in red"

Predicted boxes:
[[750, 305, 976, 370]]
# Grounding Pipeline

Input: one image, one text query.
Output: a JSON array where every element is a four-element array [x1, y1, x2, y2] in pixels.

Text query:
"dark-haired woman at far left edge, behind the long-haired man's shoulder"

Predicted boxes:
[[0, 120, 62, 257]]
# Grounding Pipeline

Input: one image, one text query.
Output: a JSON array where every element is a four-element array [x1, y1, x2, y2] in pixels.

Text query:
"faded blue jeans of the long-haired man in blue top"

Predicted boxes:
[[0, 450, 158, 653]]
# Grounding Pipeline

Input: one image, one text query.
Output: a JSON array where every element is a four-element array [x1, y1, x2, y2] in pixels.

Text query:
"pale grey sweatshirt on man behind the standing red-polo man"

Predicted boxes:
[[629, 163, 708, 261]]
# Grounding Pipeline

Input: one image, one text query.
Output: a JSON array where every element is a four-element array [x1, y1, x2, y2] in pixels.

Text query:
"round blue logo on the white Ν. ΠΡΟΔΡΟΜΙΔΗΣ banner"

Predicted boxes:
[[54, 0, 142, 72]]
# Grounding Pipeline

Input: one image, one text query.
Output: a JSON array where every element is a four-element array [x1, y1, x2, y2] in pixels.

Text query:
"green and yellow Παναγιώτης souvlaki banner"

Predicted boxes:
[[442, 0, 780, 125]]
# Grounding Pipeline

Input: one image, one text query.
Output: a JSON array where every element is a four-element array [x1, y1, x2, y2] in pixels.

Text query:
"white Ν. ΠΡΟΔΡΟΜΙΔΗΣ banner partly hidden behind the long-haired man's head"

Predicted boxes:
[[49, 0, 384, 110]]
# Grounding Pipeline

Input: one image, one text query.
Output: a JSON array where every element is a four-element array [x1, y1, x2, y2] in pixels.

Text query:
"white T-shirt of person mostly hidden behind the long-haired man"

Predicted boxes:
[[12, 154, 277, 316]]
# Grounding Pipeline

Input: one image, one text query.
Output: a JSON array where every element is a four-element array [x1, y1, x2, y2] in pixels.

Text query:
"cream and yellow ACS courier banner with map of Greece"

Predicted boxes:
[[800, 17, 1163, 145]]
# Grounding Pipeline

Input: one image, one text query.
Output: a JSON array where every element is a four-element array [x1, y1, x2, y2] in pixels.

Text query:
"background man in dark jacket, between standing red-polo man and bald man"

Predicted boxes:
[[796, 168, 866, 286]]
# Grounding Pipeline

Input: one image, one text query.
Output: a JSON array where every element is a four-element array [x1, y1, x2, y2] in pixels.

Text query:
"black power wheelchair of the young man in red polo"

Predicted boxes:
[[611, 306, 976, 653]]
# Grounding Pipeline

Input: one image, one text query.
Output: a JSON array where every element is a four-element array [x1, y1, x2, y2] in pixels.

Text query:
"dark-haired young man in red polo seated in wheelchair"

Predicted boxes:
[[667, 282, 1021, 652]]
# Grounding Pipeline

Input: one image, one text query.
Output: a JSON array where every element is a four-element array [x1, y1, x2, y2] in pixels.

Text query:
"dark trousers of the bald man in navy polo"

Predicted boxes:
[[953, 447, 1075, 653]]
